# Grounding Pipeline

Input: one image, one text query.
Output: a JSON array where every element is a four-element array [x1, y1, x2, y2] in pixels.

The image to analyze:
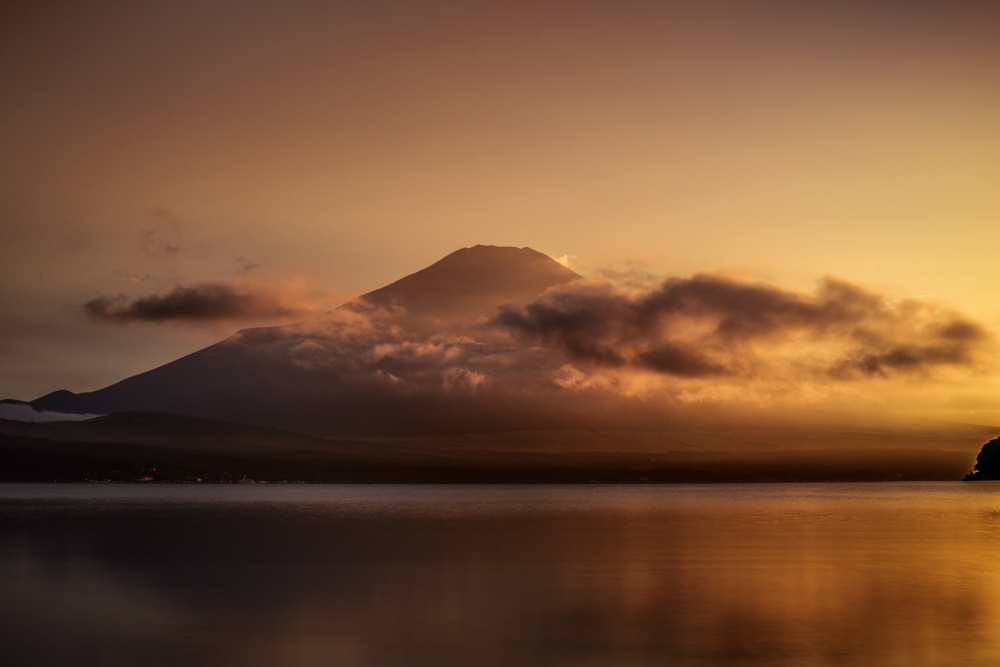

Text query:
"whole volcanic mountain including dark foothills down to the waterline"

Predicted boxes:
[[0, 246, 996, 483]]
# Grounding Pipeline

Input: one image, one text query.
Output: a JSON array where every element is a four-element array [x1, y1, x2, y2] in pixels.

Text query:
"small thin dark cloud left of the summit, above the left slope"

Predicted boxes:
[[83, 282, 306, 324]]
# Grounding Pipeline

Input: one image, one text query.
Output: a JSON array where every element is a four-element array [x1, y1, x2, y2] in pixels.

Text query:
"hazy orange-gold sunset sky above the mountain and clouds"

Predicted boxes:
[[0, 1, 1000, 423]]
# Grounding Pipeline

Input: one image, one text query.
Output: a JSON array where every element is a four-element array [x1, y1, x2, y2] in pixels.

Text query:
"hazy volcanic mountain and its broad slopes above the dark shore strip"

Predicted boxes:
[[8, 246, 996, 468]]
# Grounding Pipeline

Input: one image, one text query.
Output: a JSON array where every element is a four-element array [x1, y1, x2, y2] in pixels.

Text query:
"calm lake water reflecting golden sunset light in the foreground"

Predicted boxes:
[[0, 482, 1000, 667]]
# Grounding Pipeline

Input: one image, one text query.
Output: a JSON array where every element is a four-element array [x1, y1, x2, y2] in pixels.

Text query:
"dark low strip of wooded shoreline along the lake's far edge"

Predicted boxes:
[[0, 435, 972, 484]]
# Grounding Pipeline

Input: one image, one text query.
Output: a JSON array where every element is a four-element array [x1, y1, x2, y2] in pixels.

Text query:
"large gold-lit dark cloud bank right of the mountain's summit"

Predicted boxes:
[[492, 274, 987, 380]]
